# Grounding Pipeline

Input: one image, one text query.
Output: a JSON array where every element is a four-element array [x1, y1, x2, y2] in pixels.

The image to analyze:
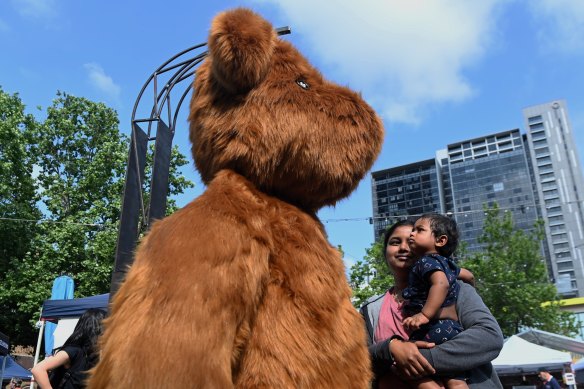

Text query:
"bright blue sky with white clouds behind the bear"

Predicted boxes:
[[0, 0, 584, 265]]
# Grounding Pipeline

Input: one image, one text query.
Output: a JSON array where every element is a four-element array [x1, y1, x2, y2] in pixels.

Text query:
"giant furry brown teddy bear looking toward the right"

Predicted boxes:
[[90, 9, 383, 389]]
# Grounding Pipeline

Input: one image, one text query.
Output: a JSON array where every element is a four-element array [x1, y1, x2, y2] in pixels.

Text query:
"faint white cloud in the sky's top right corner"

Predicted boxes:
[[528, 0, 584, 54]]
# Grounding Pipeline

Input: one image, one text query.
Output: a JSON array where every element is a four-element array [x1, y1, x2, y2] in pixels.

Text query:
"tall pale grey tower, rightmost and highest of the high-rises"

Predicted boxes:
[[523, 100, 584, 296]]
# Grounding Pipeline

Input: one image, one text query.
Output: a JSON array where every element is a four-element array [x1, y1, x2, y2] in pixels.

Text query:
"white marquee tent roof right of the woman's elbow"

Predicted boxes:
[[493, 335, 572, 375]]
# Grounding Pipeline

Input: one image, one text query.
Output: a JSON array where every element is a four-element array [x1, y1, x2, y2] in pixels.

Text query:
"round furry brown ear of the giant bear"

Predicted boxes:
[[208, 8, 278, 94]]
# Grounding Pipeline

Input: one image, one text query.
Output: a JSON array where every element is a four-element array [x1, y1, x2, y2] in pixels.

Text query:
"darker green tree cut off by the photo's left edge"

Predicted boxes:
[[0, 88, 41, 346]]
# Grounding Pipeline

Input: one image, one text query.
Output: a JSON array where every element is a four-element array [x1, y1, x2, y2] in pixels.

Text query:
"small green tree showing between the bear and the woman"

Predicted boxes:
[[349, 238, 393, 307]]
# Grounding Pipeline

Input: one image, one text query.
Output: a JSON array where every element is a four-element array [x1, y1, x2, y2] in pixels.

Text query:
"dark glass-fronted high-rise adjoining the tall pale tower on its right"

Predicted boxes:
[[447, 129, 537, 251]]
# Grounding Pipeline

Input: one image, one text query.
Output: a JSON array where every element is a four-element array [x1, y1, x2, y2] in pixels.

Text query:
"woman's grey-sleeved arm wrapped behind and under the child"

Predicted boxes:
[[420, 282, 503, 374]]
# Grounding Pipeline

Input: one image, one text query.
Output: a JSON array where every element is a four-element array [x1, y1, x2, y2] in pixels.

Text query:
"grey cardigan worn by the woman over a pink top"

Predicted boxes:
[[360, 281, 503, 389]]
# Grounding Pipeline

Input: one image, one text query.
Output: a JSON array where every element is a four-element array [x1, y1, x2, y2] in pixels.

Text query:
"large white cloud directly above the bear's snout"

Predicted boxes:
[[253, 0, 502, 123]]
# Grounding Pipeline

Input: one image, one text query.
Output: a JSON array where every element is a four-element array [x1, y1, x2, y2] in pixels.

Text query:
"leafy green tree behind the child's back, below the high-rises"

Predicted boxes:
[[461, 205, 577, 336]]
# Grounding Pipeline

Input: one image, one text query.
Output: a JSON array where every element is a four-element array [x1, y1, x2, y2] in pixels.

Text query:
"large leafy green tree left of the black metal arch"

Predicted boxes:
[[0, 92, 192, 344]]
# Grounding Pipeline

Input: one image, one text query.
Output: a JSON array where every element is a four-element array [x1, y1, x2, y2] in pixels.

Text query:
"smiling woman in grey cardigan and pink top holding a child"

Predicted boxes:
[[361, 221, 503, 389]]
